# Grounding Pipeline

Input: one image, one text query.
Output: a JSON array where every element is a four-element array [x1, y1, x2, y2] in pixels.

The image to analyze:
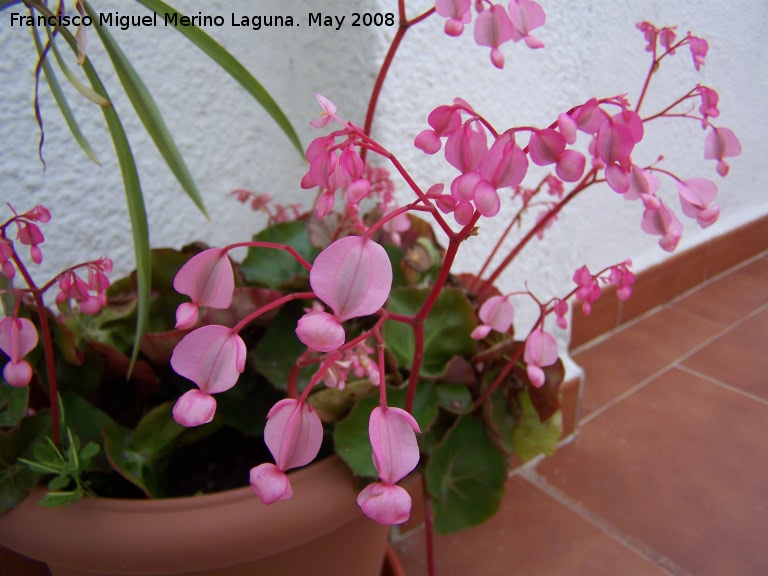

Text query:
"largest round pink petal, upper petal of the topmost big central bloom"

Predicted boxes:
[[309, 236, 392, 322]]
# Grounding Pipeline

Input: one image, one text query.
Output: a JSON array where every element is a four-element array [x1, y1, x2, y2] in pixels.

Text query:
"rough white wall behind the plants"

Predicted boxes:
[[0, 0, 768, 342]]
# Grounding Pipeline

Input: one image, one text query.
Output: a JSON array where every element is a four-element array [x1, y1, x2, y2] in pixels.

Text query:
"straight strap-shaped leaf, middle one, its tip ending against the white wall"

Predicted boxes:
[[83, 0, 206, 214]]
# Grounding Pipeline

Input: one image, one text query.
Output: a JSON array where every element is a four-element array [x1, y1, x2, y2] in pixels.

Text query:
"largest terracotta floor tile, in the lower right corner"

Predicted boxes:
[[537, 369, 768, 576]]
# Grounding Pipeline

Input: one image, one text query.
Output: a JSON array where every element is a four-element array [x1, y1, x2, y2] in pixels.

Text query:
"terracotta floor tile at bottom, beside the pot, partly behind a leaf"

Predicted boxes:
[[395, 476, 666, 576]]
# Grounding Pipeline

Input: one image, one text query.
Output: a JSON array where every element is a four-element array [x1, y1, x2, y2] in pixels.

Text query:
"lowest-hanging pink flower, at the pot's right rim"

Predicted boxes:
[[357, 406, 420, 525]]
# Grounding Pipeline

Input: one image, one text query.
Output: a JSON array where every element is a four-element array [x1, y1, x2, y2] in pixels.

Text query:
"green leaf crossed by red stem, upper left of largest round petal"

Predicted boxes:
[[240, 220, 319, 290]]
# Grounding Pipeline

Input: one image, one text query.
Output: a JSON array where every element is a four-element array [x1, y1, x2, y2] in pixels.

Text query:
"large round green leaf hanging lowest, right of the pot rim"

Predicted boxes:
[[425, 416, 507, 534]]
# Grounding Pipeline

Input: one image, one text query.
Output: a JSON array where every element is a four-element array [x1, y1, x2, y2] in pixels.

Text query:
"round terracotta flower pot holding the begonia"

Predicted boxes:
[[0, 457, 388, 576]]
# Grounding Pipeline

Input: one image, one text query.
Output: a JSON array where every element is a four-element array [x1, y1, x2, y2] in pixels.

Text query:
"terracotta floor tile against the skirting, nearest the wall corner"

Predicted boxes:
[[573, 308, 721, 415]]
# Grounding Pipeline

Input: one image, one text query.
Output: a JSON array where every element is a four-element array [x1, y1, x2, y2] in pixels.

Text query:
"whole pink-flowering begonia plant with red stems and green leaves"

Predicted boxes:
[[0, 0, 740, 572]]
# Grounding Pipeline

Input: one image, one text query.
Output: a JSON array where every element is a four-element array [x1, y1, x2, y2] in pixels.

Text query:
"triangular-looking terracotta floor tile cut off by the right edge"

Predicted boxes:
[[683, 308, 768, 400]]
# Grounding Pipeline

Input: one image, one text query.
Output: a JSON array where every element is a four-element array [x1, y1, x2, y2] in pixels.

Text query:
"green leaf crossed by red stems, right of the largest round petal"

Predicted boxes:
[[384, 288, 476, 377]]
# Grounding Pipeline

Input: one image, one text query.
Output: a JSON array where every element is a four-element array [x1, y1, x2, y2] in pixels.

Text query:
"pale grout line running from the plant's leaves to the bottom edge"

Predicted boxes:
[[519, 467, 694, 576]]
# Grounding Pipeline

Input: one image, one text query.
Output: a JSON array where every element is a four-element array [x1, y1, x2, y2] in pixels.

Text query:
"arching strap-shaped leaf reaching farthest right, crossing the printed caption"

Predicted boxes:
[[136, 0, 304, 158]]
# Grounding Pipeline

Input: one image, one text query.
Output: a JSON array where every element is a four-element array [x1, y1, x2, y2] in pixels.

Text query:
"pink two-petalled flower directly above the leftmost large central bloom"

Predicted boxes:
[[173, 248, 235, 330]]
